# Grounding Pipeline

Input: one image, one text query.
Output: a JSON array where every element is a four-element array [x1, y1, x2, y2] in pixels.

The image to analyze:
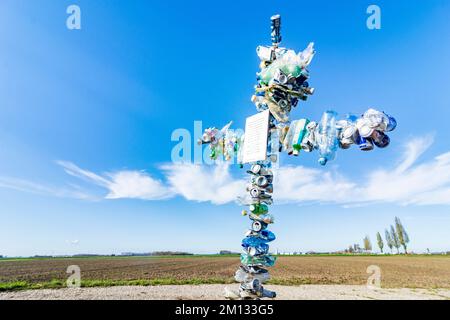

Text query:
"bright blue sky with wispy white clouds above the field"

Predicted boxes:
[[0, 0, 450, 256]]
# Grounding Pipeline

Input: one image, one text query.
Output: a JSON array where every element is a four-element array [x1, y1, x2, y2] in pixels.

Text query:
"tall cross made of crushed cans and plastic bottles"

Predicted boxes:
[[199, 15, 396, 299]]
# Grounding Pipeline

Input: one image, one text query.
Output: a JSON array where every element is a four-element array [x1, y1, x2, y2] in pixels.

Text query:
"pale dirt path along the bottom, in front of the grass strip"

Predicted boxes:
[[0, 285, 450, 300]]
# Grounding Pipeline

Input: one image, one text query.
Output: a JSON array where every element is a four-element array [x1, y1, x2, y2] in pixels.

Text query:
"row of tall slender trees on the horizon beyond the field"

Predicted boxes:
[[345, 217, 409, 254]]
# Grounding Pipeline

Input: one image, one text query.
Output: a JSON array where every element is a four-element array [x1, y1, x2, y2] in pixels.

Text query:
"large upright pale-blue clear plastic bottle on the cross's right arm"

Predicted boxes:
[[316, 110, 339, 166]]
